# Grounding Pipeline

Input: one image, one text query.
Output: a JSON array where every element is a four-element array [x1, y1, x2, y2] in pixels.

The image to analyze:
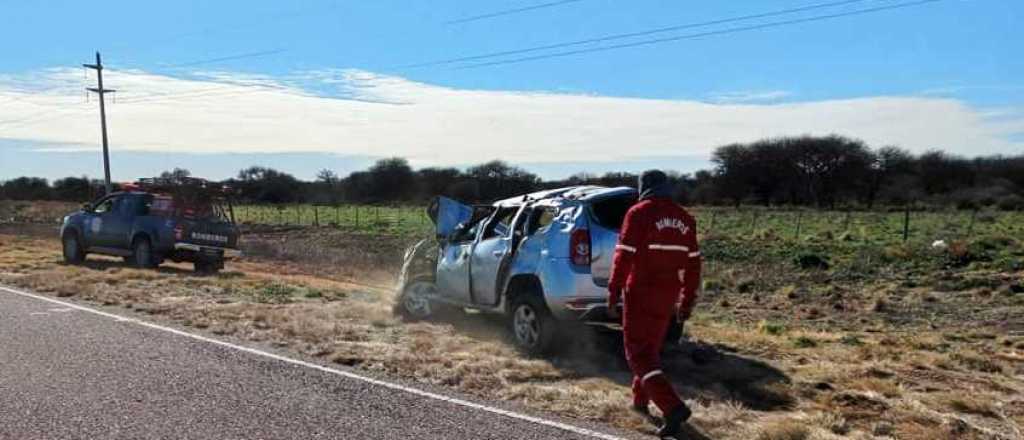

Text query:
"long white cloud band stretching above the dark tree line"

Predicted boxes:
[[0, 69, 1024, 166]]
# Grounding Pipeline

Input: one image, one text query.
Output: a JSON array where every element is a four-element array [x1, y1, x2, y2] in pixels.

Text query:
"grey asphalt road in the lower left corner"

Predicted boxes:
[[0, 288, 633, 440]]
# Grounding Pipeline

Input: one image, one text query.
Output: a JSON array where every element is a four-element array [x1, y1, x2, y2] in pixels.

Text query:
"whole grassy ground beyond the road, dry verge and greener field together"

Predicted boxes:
[[0, 222, 1024, 440]]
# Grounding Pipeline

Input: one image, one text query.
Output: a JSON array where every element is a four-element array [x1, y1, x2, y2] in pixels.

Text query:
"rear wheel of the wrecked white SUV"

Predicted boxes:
[[509, 295, 558, 356]]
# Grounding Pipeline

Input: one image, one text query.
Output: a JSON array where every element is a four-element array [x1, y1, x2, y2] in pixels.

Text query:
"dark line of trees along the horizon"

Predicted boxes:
[[0, 135, 1024, 210]]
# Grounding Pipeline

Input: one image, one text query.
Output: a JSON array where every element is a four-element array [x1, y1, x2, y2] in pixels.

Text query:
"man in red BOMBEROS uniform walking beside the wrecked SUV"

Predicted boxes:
[[608, 170, 700, 437]]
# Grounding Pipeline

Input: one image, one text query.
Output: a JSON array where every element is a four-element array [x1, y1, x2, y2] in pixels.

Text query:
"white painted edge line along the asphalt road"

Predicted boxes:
[[0, 285, 626, 440]]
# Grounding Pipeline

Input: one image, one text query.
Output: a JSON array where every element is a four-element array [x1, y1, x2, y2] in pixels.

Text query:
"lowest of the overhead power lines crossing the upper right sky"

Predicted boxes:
[[456, 0, 942, 70]]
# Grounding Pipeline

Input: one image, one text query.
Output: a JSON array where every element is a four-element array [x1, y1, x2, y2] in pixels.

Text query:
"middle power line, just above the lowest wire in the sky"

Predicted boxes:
[[402, 0, 867, 69]]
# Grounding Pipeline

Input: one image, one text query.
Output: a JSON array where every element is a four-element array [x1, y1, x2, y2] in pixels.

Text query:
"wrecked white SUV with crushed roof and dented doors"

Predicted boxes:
[[396, 186, 675, 354]]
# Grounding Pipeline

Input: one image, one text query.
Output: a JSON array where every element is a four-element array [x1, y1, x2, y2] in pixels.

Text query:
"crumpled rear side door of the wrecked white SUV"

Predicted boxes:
[[469, 207, 520, 306]]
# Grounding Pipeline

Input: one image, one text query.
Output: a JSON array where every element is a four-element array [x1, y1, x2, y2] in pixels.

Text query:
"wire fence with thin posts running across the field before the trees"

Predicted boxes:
[[0, 201, 1024, 245]]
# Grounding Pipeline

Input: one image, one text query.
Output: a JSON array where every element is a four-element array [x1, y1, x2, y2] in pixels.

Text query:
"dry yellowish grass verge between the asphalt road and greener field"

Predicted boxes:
[[0, 234, 1024, 440]]
